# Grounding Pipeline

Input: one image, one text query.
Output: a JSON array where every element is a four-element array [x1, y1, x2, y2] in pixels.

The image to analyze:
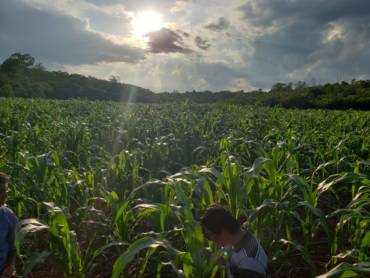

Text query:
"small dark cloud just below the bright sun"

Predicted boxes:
[[146, 28, 192, 54]]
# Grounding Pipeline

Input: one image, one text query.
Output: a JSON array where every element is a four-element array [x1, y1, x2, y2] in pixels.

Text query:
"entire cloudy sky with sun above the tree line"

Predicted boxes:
[[0, 0, 370, 92]]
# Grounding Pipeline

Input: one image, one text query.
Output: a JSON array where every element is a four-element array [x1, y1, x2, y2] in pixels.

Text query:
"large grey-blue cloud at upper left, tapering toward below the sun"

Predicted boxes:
[[0, 0, 144, 64]]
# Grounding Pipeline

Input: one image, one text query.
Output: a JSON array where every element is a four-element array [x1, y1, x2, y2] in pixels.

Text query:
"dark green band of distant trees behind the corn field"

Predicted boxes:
[[0, 53, 370, 110]]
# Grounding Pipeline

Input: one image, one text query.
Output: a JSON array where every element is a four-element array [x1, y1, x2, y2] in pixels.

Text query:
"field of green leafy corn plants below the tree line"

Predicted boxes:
[[0, 99, 370, 278]]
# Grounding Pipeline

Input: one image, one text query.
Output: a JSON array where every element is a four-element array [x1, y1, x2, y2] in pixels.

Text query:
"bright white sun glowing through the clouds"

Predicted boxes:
[[131, 11, 164, 38]]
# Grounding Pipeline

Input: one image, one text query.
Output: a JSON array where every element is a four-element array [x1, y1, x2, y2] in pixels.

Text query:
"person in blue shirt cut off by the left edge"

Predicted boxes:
[[0, 172, 18, 278]]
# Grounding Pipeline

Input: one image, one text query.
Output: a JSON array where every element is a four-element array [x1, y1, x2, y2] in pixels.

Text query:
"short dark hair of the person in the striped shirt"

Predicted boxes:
[[201, 205, 240, 234]]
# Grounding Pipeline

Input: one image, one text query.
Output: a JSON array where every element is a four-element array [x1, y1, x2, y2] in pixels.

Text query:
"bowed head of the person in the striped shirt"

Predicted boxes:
[[201, 205, 241, 245]]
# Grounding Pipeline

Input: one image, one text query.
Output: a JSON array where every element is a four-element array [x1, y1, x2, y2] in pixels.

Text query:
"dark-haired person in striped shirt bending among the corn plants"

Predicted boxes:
[[201, 205, 269, 278]]
